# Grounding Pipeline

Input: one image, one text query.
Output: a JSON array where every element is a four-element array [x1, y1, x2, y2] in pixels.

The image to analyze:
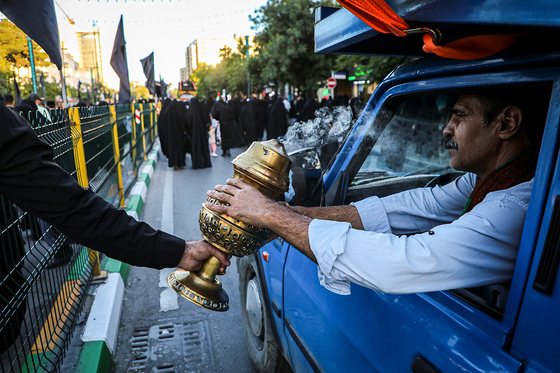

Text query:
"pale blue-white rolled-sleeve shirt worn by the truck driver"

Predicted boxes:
[[309, 174, 533, 294]]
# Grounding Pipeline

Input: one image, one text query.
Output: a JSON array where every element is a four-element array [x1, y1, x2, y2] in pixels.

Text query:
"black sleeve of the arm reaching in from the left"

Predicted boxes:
[[0, 106, 185, 269]]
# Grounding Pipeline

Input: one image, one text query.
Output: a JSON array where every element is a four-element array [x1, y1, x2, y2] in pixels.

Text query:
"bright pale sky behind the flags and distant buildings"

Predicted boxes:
[[54, 0, 266, 89]]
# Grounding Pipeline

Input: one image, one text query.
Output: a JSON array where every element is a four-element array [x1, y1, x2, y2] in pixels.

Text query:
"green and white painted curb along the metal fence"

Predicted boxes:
[[76, 142, 161, 373]]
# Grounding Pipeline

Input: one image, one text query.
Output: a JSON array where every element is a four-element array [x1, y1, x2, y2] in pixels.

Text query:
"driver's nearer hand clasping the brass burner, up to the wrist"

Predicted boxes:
[[204, 179, 283, 229]]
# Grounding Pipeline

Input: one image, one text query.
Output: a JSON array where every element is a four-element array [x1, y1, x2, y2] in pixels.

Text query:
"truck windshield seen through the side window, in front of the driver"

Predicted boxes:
[[347, 93, 460, 202]]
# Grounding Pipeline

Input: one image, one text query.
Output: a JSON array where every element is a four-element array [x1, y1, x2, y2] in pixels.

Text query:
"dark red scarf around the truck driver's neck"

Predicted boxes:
[[461, 149, 538, 215]]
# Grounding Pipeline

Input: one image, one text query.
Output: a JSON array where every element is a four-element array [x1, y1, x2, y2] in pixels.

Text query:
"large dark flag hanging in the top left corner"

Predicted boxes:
[[0, 0, 62, 70]]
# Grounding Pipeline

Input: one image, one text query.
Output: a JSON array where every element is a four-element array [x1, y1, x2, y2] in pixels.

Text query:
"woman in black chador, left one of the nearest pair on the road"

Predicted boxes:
[[167, 101, 191, 170]]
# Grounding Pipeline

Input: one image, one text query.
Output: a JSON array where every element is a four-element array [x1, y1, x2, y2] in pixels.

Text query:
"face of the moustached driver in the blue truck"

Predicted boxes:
[[443, 95, 500, 177]]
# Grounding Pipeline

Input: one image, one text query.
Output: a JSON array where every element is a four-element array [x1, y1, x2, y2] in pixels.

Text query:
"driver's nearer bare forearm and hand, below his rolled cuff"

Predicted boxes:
[[205, 179, 317, 262]]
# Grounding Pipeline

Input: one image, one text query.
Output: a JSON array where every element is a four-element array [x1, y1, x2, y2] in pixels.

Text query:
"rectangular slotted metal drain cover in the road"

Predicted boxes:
[[127, 315, 214, 373]]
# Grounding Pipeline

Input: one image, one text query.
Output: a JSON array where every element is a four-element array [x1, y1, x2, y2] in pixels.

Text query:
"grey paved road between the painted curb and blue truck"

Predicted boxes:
[[114, 148, 256, 373]]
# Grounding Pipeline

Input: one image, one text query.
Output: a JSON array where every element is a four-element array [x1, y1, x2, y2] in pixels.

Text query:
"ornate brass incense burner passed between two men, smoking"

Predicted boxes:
[[167, 140, 291, 311]]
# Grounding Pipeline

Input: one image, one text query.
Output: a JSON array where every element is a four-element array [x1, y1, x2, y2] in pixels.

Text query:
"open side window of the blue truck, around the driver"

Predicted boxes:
[[345, 85, 551, 320]]
